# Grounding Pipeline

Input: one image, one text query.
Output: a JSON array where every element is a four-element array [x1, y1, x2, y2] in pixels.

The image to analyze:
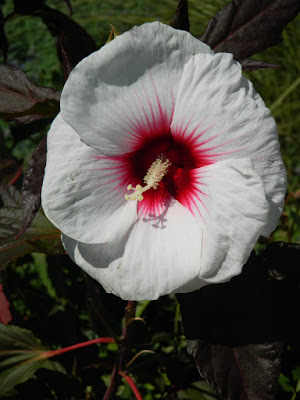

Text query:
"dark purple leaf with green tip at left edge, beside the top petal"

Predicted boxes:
[[0, 64, 60, 122]]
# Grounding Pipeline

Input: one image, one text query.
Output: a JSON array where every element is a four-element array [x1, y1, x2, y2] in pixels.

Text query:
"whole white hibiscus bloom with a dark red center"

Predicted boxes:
[[42, 22, 286, 300]]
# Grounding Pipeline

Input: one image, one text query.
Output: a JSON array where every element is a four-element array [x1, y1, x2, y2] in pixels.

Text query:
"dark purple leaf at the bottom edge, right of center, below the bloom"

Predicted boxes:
[[187, 339, 283, 400]]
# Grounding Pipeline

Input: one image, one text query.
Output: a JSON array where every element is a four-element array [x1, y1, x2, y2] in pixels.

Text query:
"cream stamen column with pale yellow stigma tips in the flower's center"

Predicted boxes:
[[125, 156, 171, 201]]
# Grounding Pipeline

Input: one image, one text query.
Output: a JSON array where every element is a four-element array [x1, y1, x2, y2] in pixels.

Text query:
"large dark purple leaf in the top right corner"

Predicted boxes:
[[200, 0, 300, 60]]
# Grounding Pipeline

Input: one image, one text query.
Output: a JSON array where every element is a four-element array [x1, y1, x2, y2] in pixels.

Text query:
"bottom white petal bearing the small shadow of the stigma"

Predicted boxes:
[[63, 200, 202, 300]]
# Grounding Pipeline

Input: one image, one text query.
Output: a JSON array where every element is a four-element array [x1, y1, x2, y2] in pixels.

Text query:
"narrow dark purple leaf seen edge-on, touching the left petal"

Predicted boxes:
[[16, 136, 47, 239]]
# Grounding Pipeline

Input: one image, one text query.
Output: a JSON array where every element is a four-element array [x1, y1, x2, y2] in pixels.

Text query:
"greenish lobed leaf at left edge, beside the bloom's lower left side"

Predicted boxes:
[[0, 186, 64, 269]]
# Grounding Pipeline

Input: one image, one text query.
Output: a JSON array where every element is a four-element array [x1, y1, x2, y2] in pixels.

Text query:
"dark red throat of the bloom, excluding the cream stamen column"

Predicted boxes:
[[126, 132, 210, 216]]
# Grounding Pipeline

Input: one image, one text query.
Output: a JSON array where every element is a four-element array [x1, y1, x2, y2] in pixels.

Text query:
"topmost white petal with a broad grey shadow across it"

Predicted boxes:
[[61, 22, 212, 155]]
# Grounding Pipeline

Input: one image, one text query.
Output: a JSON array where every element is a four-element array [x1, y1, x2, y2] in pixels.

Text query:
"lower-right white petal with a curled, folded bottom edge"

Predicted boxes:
[[184, 159, 269, 291]]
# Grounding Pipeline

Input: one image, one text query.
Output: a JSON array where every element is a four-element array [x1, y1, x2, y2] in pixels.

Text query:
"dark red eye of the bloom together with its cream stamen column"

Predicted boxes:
[[125, 132, 211, 216]]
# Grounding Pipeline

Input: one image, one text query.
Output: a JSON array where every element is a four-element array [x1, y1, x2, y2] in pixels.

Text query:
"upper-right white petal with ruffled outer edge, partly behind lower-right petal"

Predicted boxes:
[[171, 53, 286, 235]]
